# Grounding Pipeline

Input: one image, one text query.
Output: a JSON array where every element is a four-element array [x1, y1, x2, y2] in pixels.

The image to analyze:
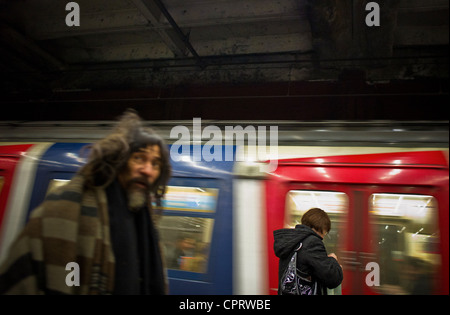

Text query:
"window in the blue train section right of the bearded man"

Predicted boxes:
[[159, 186, 218, 273]]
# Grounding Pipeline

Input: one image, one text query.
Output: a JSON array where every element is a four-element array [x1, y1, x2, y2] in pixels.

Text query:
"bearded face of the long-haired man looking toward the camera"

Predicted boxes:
[[118, 144, 161, 208]]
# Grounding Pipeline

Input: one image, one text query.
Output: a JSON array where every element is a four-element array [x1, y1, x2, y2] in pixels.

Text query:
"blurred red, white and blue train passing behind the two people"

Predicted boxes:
[[0, 121, 449, 294]]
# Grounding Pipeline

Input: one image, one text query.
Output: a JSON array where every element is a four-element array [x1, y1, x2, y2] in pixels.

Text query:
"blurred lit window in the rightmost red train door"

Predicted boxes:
[[370, 194, 441, 294]]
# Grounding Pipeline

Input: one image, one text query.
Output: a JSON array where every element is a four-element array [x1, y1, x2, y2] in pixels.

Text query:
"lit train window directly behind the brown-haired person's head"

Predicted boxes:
[[285, 190, 348, 253]]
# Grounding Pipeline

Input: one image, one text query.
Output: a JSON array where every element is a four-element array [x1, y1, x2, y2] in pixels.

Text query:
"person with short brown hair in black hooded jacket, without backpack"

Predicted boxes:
[[273, 208, 343, 295]]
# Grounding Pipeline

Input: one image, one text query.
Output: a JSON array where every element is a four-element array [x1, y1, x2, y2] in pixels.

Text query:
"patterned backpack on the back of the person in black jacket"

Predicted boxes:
[[279, 243, 318, 295]]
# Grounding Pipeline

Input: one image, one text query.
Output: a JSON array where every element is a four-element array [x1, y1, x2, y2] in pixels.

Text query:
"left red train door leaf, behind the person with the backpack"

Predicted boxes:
[[266, 178, 352, 294]]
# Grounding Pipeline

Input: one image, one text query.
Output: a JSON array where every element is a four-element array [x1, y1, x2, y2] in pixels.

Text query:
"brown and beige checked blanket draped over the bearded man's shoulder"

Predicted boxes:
[[0, 175, 115, 294]]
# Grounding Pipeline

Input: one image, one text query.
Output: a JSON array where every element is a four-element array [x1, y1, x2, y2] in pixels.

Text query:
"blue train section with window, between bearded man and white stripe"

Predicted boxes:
[[158, 146, 234, 295]]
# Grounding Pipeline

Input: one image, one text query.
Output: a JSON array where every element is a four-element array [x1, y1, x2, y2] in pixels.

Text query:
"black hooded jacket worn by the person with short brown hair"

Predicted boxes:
[[273, 225, 343, 294]]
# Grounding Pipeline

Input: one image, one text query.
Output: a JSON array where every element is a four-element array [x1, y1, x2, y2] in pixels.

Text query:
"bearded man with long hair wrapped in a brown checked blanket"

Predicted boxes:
[[0, 110, 171, 294]]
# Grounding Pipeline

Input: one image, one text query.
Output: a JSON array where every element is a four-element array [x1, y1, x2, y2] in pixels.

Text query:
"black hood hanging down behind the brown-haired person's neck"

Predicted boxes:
[[273, 225, 321, 258]]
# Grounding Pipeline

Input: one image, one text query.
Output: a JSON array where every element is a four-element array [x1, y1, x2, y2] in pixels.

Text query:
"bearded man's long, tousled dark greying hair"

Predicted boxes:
[[79, 109, 172, 204]]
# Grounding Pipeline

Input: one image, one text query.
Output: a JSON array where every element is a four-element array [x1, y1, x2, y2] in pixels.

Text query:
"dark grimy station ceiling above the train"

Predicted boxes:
[[0, 0, 449, 121]]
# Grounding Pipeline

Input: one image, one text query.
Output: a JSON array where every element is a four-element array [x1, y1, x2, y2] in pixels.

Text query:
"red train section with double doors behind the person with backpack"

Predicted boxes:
[[266, 152, 448, 294]]
